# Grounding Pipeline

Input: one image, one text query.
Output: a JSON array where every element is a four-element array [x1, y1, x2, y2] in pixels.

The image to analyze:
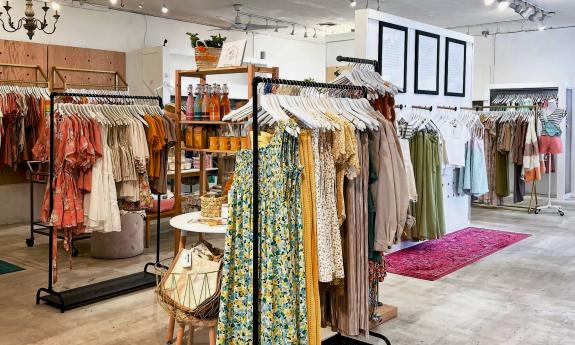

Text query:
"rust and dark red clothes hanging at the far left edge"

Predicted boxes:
[[0, 85, 49, 169]]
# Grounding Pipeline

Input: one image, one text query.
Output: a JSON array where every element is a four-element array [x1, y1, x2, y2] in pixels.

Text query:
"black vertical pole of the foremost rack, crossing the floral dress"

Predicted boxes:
[[252, 77, 260, 345]]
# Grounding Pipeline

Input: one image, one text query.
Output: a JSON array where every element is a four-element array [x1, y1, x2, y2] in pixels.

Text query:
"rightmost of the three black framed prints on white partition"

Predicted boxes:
[[445, 37, 467, 97]]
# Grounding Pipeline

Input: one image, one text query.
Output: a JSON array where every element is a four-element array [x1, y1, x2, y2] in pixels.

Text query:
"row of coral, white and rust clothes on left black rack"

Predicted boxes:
[[33, 99, 175, 282]]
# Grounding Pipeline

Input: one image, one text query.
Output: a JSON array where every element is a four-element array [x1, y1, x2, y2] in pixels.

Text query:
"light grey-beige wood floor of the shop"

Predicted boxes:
[[0, 200, 575, 345]]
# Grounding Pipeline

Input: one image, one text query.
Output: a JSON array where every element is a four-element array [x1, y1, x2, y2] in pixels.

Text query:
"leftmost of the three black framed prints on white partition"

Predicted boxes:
[[378, 22, 408, 93]]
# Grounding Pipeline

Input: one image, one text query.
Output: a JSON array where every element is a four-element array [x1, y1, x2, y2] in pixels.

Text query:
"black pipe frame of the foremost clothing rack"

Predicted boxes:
[[252, 76, 391, 345]]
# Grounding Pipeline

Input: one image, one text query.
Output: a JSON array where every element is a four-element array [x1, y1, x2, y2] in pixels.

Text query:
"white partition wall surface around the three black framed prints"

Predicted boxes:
[[354, 10, 474, 232]]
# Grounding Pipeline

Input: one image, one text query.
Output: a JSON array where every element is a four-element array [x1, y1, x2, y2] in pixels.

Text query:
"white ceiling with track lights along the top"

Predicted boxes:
[[80, 0, 575, 32]]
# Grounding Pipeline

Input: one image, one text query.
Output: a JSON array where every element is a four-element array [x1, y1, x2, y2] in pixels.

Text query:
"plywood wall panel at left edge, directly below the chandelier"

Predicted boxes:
[[0, 40, 48, 81]]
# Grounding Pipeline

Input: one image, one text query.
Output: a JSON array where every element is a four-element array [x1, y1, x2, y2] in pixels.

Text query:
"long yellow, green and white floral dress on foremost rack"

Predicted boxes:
[[217, 125, 308, 345]]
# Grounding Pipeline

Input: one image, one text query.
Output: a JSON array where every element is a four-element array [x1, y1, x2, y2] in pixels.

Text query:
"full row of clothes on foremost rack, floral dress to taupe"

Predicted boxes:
[[218, 80, 408, 345]]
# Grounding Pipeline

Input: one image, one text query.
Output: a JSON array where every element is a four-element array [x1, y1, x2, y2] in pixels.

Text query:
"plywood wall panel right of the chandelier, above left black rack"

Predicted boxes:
[[48, 45, 126, 88]]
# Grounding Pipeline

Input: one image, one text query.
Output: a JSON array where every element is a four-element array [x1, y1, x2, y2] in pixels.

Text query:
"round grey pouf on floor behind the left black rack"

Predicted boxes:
[[91, 212, 145, 259]]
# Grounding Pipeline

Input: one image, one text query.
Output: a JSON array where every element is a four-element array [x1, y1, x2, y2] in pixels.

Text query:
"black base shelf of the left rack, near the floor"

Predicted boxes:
[[36, 271, 156, 313]]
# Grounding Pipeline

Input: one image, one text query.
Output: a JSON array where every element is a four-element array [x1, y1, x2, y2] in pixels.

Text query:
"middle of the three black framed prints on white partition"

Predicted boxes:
[[415, 30, 439, 95]]
